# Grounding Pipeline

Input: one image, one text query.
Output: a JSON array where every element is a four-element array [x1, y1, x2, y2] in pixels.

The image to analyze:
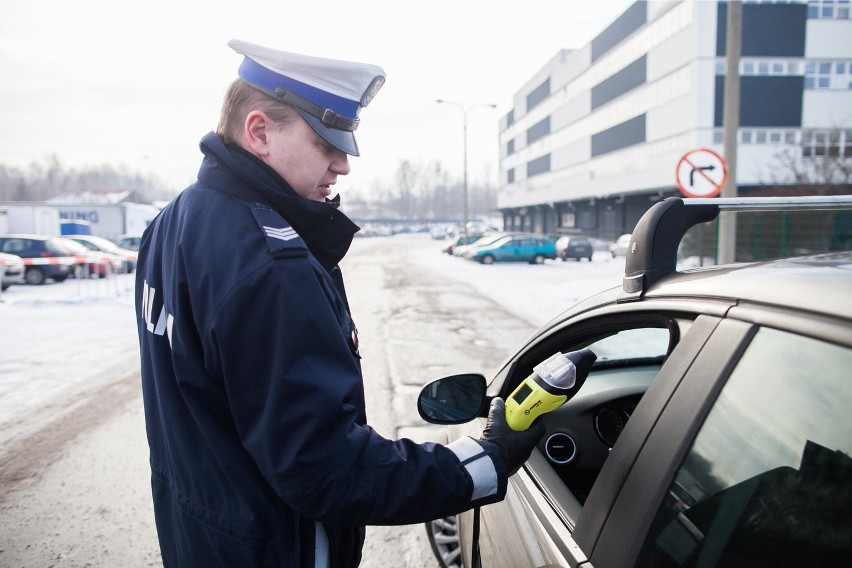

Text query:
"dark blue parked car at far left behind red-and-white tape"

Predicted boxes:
[[0, 234, 77, 284]]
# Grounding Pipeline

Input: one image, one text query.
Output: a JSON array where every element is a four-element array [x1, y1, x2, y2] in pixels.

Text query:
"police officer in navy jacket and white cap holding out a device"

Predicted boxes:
[[136, 40, 543, 568]]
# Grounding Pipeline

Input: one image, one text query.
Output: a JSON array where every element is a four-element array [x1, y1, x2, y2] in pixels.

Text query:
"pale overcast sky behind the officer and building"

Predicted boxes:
[[0, 0, 632, 195]]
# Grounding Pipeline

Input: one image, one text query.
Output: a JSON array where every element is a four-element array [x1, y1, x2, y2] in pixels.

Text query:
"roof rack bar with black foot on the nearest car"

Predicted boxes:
[[618, 195, 852, 302]]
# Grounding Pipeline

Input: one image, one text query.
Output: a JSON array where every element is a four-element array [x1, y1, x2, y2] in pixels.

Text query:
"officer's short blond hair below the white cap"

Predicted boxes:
[[216, 79, 296, 144]]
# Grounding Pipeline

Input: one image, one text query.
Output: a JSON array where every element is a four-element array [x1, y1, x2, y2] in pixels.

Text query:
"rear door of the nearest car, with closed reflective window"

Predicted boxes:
[[574, 318, 852, 568]]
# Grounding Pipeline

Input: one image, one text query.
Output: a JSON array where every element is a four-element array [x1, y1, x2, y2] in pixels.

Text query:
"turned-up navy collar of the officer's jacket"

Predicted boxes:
[[198, 132, 360, 270]]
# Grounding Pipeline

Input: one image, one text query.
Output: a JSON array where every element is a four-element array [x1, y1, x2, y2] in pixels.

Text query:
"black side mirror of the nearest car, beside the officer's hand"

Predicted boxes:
[[417, 373, 486, 424]]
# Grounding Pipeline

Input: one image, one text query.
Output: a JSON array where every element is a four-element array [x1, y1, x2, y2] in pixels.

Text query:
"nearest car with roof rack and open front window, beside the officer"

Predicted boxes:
[[418, 196, 852, 568]]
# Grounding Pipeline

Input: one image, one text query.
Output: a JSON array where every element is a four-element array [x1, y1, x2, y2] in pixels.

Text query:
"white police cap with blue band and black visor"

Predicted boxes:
[[228, 39, 385, 156]]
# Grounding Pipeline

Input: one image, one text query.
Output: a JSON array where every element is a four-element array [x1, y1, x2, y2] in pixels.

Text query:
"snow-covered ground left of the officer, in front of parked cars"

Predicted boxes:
[[0, 274, 139, 447]]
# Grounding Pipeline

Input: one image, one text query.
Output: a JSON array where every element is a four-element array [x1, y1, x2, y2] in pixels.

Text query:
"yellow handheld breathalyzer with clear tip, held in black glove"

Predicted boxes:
[[506, 349, 597, 432]]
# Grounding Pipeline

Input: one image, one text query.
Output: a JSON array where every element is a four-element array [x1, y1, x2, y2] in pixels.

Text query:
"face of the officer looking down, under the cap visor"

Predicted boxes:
[[265, 117, 350, 201]]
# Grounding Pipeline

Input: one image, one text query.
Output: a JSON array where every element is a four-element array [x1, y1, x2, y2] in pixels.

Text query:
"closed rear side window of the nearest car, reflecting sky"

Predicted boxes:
[[637, 329, 852, 568]]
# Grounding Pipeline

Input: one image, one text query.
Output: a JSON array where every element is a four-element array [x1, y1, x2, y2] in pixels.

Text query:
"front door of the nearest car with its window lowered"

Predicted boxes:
[[451, 300, 715, 568]]
